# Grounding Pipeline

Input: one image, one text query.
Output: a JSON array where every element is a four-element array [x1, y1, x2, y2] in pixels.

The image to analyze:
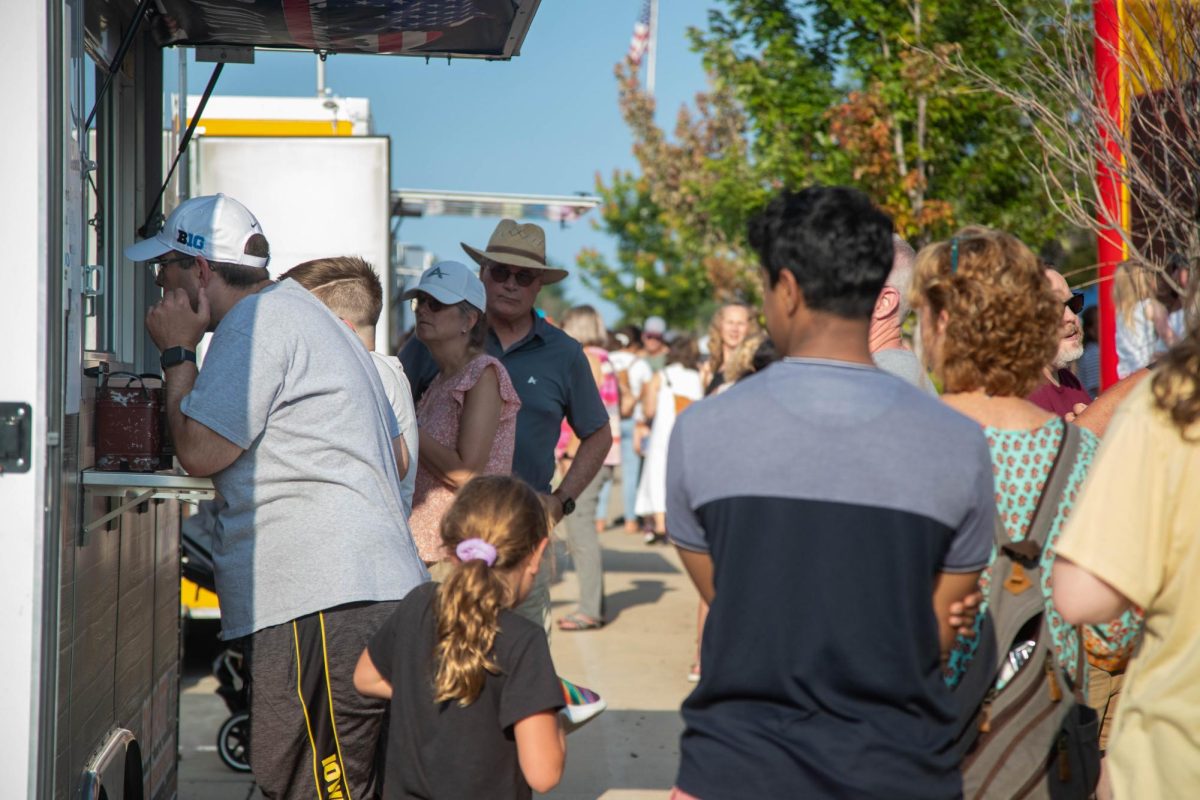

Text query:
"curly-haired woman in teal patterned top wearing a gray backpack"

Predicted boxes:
[[912, 227, 1140, 796]]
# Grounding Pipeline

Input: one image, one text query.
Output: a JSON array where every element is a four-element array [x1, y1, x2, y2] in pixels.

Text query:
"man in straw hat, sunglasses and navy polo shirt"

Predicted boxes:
[[400, 219, 612, 630]]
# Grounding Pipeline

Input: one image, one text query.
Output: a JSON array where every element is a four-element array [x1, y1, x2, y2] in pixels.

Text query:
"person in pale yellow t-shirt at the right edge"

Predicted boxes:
[[1054, 316, 1200, 798]]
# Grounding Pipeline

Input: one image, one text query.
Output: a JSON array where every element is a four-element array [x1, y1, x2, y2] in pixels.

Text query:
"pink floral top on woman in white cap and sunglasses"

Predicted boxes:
[[408, 355, 521, 564]]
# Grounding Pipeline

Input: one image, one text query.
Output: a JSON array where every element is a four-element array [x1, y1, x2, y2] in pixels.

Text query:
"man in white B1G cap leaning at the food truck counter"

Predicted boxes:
[[126, 194, 428, 799]]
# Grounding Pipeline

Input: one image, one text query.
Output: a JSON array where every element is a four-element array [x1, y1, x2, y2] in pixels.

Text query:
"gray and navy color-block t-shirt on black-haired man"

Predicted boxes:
[[667, 359, 996, 800]]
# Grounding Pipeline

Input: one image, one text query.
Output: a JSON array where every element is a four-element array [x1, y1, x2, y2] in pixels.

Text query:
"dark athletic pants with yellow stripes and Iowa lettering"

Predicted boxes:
[[246, 601, 396, 800]]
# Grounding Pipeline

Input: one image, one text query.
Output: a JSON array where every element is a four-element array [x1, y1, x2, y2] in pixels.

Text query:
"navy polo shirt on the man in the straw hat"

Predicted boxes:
[[400, 314, 608, 492]]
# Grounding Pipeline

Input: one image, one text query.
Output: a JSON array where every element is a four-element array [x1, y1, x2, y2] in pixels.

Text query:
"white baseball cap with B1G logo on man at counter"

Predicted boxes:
[[125, 194, 271, 266]]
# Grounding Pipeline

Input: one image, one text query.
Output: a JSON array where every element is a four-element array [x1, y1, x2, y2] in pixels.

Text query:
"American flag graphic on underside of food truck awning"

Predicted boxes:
[[282, 0, 486, 53]]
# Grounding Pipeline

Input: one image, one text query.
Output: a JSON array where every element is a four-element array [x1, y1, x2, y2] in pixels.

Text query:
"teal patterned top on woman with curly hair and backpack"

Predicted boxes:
[[944, 417, 1140, 690]]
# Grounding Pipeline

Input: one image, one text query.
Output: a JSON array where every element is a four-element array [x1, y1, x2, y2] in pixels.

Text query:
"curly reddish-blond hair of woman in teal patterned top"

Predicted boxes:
[[910, 225, 1062, 397]]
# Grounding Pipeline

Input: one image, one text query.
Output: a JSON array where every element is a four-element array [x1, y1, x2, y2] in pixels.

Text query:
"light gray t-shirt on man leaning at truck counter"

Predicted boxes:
[[180, 281, 428, 639]]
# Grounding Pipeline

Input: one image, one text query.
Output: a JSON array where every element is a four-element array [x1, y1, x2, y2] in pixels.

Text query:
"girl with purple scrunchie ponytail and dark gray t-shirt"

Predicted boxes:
[[354, 475, 566, 799]]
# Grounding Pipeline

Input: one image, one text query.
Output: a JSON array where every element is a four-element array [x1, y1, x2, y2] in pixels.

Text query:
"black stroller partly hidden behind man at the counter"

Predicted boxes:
[[179, 501, 250, 772]]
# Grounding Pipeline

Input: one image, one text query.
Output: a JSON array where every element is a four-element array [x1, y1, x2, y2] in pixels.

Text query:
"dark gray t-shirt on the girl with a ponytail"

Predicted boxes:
[[367, 583, 564, 800]]
